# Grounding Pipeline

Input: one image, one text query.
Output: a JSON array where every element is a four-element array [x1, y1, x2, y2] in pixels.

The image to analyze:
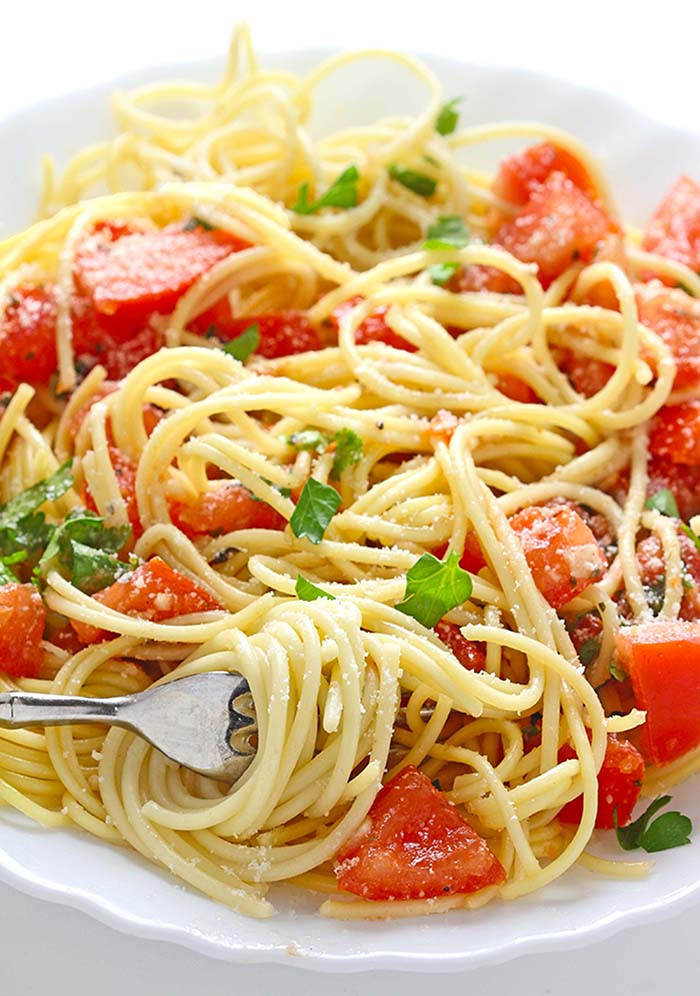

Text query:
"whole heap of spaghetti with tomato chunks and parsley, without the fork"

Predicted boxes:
[[0, 29, 700, 917]]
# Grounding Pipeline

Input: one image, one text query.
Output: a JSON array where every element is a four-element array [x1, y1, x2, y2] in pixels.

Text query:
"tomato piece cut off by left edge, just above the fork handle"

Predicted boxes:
[[0, 583, 46, 678]]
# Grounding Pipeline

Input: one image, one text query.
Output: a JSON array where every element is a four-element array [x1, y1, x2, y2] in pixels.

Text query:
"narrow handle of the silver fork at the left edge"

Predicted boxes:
[[0, 692, 131, 730]]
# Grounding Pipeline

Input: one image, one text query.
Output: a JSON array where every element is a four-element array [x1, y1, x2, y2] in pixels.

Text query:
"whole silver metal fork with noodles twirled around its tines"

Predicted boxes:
[[0, 671, 258, 782]]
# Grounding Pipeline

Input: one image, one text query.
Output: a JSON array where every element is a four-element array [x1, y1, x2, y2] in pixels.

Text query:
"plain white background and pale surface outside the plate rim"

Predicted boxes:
[[0, 0, 700, 996]]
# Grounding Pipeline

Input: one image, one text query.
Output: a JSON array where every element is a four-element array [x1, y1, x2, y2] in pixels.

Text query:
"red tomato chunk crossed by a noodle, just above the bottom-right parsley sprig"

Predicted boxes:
[[559, 733, 644, 830]]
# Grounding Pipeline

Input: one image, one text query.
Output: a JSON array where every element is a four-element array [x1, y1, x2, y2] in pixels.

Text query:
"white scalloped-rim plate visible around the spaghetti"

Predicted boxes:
[[0, 52, 700, 972]]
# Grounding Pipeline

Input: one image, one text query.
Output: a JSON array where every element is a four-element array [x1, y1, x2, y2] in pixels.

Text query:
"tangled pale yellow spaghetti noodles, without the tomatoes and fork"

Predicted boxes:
[[0, 23, 700, 917]]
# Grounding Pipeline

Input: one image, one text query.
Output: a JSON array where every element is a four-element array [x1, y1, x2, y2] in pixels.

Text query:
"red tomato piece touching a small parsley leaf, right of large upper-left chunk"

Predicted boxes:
[[190, 298, 322, 360]]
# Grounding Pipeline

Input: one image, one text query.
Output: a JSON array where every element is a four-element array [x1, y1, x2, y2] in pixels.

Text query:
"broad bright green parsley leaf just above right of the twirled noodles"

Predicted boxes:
[[396, 550, 472, 629]]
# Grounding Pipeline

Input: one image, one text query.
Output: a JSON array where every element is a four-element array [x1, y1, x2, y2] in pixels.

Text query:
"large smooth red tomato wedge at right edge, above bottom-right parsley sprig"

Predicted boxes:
[[615, 620, 700, 764]]
